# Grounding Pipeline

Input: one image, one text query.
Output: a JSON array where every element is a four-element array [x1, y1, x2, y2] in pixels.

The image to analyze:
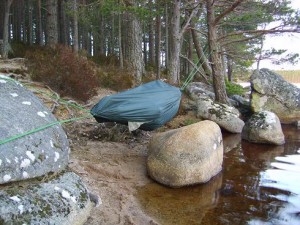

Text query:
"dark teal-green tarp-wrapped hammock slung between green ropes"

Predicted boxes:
[[91, 80, 181, 131]]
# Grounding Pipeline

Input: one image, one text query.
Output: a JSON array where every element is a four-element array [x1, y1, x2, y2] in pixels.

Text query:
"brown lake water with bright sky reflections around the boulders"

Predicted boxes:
[[137, 125, 300, 225]]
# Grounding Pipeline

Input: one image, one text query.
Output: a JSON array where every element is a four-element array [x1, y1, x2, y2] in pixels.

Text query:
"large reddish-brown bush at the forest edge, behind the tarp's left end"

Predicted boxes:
[[26, 45, 98, 101]]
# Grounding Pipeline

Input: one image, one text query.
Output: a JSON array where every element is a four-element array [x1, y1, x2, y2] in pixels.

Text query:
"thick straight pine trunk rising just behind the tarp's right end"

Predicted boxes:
[[168, 0, 181, 84]]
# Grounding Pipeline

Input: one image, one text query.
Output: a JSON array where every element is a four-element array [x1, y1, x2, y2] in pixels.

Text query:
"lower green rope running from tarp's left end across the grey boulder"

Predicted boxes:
[[0, 115, 92, 145]]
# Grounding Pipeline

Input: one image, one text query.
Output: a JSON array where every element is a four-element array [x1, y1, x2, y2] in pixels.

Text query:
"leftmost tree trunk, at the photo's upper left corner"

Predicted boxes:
[[2, 0, 13, 59]]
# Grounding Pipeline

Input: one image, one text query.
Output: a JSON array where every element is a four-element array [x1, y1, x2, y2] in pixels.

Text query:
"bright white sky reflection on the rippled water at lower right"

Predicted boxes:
[[254, 150, 300, 225]]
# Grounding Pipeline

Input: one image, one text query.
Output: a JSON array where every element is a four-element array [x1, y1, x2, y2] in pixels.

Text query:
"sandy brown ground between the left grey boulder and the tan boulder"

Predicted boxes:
[[0, 59, 198, 225]]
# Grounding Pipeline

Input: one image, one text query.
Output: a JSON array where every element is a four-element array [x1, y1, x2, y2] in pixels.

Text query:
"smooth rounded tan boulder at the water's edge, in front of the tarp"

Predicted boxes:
[[147, 120, 223, 187]]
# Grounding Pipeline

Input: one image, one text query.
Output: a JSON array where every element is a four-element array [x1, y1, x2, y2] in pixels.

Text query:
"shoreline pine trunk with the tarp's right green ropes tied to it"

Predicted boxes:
[[206, 0, 229, 104]]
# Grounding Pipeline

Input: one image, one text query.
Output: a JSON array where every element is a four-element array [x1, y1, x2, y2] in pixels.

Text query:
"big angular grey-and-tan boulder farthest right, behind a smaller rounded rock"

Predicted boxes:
[[250, 69, 300, 123]]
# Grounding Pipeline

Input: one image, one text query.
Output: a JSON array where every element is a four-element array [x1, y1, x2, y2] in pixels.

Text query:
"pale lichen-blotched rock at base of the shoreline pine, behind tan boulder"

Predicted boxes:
[[197, 97, 245, 133]]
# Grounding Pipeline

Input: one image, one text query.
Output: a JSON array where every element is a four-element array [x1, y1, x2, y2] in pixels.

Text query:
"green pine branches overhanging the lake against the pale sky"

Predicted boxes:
[[217, 0, 300, 75]]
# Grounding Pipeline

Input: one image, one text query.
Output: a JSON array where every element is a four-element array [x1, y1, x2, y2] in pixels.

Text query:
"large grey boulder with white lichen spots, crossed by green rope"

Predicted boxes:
[[0, 76, 69, 184]]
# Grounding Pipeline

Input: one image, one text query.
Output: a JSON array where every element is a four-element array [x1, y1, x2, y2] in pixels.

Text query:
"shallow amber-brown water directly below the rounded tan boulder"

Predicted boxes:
[[138, 174, 222, 225]]
